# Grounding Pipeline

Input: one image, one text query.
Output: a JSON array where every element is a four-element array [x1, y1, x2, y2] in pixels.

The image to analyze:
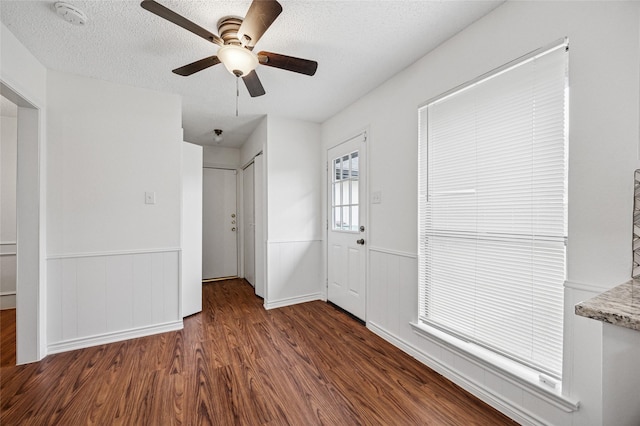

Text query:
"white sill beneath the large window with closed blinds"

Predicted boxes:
[[411, 322, 580, 413]]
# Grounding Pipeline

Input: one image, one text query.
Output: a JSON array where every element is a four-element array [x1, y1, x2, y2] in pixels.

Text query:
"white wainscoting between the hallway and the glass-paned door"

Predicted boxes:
[[264, 240, 324, 309]]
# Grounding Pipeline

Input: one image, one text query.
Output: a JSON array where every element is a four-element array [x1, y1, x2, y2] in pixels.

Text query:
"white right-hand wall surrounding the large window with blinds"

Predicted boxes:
[[322, 2, 640, 425]]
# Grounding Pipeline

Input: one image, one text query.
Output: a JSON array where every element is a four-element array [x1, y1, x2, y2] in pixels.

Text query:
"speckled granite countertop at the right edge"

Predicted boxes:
[[575, 279, 640, 331]]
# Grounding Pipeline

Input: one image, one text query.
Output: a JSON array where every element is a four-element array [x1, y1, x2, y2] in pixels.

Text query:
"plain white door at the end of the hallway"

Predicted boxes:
[[202, 168, 238, 279]]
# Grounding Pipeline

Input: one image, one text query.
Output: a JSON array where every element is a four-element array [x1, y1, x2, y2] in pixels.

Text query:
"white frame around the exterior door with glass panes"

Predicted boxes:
[[325, 128, 371, 323]]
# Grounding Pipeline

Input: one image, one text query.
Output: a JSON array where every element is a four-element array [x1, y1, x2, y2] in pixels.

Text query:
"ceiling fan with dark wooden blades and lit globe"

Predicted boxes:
[[140, 0, 318, 97]]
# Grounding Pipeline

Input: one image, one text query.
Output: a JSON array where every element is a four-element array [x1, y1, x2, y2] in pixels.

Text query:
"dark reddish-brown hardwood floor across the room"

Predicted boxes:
[[0, 280, 515, 426]]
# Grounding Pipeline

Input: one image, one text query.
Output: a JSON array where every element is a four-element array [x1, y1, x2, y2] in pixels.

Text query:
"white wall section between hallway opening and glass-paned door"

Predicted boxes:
[[265, 116, 324, 308]]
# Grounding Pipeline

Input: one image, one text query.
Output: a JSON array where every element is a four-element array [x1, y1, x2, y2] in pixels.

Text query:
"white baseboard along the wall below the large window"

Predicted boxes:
[[367, 321, 547, 426]]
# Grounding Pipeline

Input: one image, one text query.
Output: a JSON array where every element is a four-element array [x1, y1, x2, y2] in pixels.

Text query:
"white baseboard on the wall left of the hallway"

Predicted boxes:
[[47, 320, 183, 355]]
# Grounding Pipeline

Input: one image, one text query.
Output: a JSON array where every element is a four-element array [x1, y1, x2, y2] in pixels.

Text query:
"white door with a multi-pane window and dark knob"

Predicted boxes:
[[327, 133, 367, 320]]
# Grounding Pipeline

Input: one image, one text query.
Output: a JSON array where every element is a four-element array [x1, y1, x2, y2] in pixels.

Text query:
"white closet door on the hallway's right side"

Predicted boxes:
[[242, 163, 256, 286]]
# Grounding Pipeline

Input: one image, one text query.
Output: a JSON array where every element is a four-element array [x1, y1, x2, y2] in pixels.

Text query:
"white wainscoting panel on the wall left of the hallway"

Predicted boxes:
[[47, 249, 182, 353]]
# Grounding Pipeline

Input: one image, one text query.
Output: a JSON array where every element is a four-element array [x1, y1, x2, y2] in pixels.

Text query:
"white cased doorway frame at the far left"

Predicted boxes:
[[0, 80, 47, 364]]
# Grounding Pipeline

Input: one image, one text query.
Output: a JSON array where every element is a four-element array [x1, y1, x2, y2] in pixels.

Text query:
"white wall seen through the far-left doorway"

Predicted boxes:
[[0, 112, 18, 309]]
